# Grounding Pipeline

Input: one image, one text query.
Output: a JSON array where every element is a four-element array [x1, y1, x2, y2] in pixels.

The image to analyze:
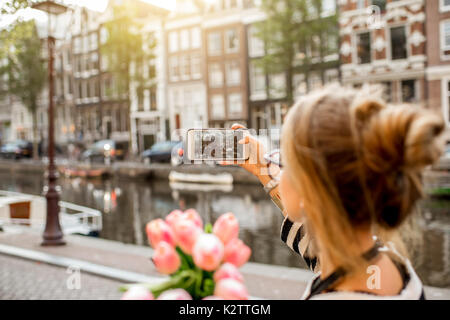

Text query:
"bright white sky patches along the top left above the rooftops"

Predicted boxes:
[[0, 0, 175, 29]]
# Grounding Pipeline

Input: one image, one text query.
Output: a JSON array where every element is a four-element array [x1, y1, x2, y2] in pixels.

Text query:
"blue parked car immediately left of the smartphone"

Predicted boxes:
[[141, 141, 183, 165]]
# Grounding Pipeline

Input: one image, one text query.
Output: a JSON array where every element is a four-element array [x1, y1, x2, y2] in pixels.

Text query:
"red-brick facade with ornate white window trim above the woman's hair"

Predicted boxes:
[[339, 0, 430, 104]]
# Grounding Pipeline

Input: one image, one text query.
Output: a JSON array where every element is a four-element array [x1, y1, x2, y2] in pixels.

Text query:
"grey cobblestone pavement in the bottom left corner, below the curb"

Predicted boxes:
[[0, 255, 121, 300]]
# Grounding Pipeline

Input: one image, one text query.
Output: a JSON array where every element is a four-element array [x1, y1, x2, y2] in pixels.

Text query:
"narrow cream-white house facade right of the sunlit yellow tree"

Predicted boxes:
[[165, 1, 208, 139]]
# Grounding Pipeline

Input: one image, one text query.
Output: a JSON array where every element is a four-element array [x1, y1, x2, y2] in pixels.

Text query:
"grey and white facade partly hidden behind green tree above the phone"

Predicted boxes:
[[244, 0, 339, 130]]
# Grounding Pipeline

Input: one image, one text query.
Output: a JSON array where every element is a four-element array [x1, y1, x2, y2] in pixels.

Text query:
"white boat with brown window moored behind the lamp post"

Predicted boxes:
[[0, 190, 102, 235]]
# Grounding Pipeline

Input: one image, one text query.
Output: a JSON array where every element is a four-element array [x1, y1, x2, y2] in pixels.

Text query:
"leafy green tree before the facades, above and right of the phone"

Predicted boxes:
[[256, 0, 338, 103]]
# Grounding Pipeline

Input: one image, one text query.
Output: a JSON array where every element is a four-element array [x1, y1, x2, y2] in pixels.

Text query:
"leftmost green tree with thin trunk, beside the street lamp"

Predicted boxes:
[[0, 20, 47, 159]]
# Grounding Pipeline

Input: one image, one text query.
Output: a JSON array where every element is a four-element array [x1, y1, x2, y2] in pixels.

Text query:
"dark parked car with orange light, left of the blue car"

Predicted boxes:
[[81, 140, 126, 162]]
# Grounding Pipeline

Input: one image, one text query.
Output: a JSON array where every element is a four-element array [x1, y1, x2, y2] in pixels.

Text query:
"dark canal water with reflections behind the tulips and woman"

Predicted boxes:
[[0, 171, 450, 288]]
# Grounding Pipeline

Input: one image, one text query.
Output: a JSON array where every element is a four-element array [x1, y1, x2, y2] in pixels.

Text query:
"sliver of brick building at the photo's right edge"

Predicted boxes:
[[426, 0, 450, 131]]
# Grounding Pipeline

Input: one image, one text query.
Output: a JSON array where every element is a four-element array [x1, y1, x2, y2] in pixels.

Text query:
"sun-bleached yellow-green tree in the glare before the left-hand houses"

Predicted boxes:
[[101, 1, 156, 155]]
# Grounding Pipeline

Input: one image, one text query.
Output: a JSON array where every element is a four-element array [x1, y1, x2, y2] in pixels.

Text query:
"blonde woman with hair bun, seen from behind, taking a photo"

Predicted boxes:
[[233, 86, 444, 299]]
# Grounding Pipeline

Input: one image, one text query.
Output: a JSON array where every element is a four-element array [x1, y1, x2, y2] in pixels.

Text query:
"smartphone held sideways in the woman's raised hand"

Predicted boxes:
[[186, 129, 249, 161]]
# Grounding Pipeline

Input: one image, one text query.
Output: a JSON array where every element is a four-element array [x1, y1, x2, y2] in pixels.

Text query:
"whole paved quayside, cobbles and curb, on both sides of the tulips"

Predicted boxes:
[[0, 232, 450, 300]]
